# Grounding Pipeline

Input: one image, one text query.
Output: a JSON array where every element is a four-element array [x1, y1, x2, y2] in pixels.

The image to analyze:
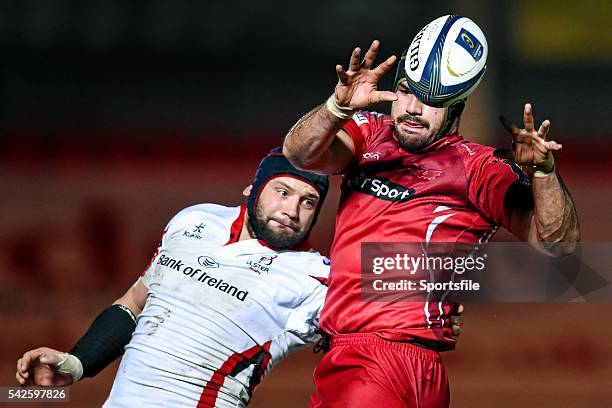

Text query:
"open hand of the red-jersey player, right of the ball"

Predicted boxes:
[[494, 103, 563, 173]]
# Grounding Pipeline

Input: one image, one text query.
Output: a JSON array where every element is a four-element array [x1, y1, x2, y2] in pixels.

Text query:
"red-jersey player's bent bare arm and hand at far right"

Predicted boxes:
[[496, 103, 580, 256]]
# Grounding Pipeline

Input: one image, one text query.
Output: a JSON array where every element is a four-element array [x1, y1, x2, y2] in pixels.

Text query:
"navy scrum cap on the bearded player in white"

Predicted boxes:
[[247, 147, 329, 220]]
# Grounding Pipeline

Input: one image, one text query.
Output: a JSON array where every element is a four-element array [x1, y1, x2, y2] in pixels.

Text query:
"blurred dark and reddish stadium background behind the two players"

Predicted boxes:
[[0, 0, 612, 407]]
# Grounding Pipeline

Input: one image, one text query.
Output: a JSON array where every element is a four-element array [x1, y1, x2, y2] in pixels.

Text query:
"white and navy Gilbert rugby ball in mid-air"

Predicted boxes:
[[402, 15, 488, 107]]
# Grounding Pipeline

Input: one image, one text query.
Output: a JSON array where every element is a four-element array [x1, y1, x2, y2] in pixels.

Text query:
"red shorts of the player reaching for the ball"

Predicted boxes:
[[309, 333, 450, 408]]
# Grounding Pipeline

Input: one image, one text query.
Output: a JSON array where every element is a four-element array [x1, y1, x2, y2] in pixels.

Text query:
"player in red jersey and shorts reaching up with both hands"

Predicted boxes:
[[284, 41, 580, 408]]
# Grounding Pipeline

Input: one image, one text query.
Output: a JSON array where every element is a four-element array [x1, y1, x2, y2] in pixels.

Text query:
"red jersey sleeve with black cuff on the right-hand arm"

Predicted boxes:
[[464, 143, 532, 228]]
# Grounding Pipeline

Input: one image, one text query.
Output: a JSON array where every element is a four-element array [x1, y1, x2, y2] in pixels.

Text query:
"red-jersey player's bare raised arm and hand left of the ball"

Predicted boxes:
[[283, 40, 397, 174]]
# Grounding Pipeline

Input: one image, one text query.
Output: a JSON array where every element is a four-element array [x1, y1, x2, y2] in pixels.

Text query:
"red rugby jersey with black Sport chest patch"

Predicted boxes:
[[320, 112, 529, 350]]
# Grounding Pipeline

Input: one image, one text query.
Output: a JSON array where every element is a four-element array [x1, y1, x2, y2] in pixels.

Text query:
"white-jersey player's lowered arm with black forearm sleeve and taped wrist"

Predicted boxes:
[[15, 279, 148, 387]]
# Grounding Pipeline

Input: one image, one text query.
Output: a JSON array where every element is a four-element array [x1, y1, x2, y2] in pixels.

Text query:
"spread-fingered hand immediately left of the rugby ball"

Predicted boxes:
[[336, 40, 397, 110]]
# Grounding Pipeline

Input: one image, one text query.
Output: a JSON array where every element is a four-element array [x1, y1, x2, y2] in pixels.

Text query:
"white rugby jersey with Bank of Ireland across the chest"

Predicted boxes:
[[104, 204, 329, 407]]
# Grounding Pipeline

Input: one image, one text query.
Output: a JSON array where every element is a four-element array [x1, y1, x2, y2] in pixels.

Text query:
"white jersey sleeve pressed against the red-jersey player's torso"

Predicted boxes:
[[287, 256, 329, 344]]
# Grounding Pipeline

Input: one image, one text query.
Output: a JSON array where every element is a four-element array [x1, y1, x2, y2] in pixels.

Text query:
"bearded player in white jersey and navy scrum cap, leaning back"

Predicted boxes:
[[16, 148, 329, 407]]
